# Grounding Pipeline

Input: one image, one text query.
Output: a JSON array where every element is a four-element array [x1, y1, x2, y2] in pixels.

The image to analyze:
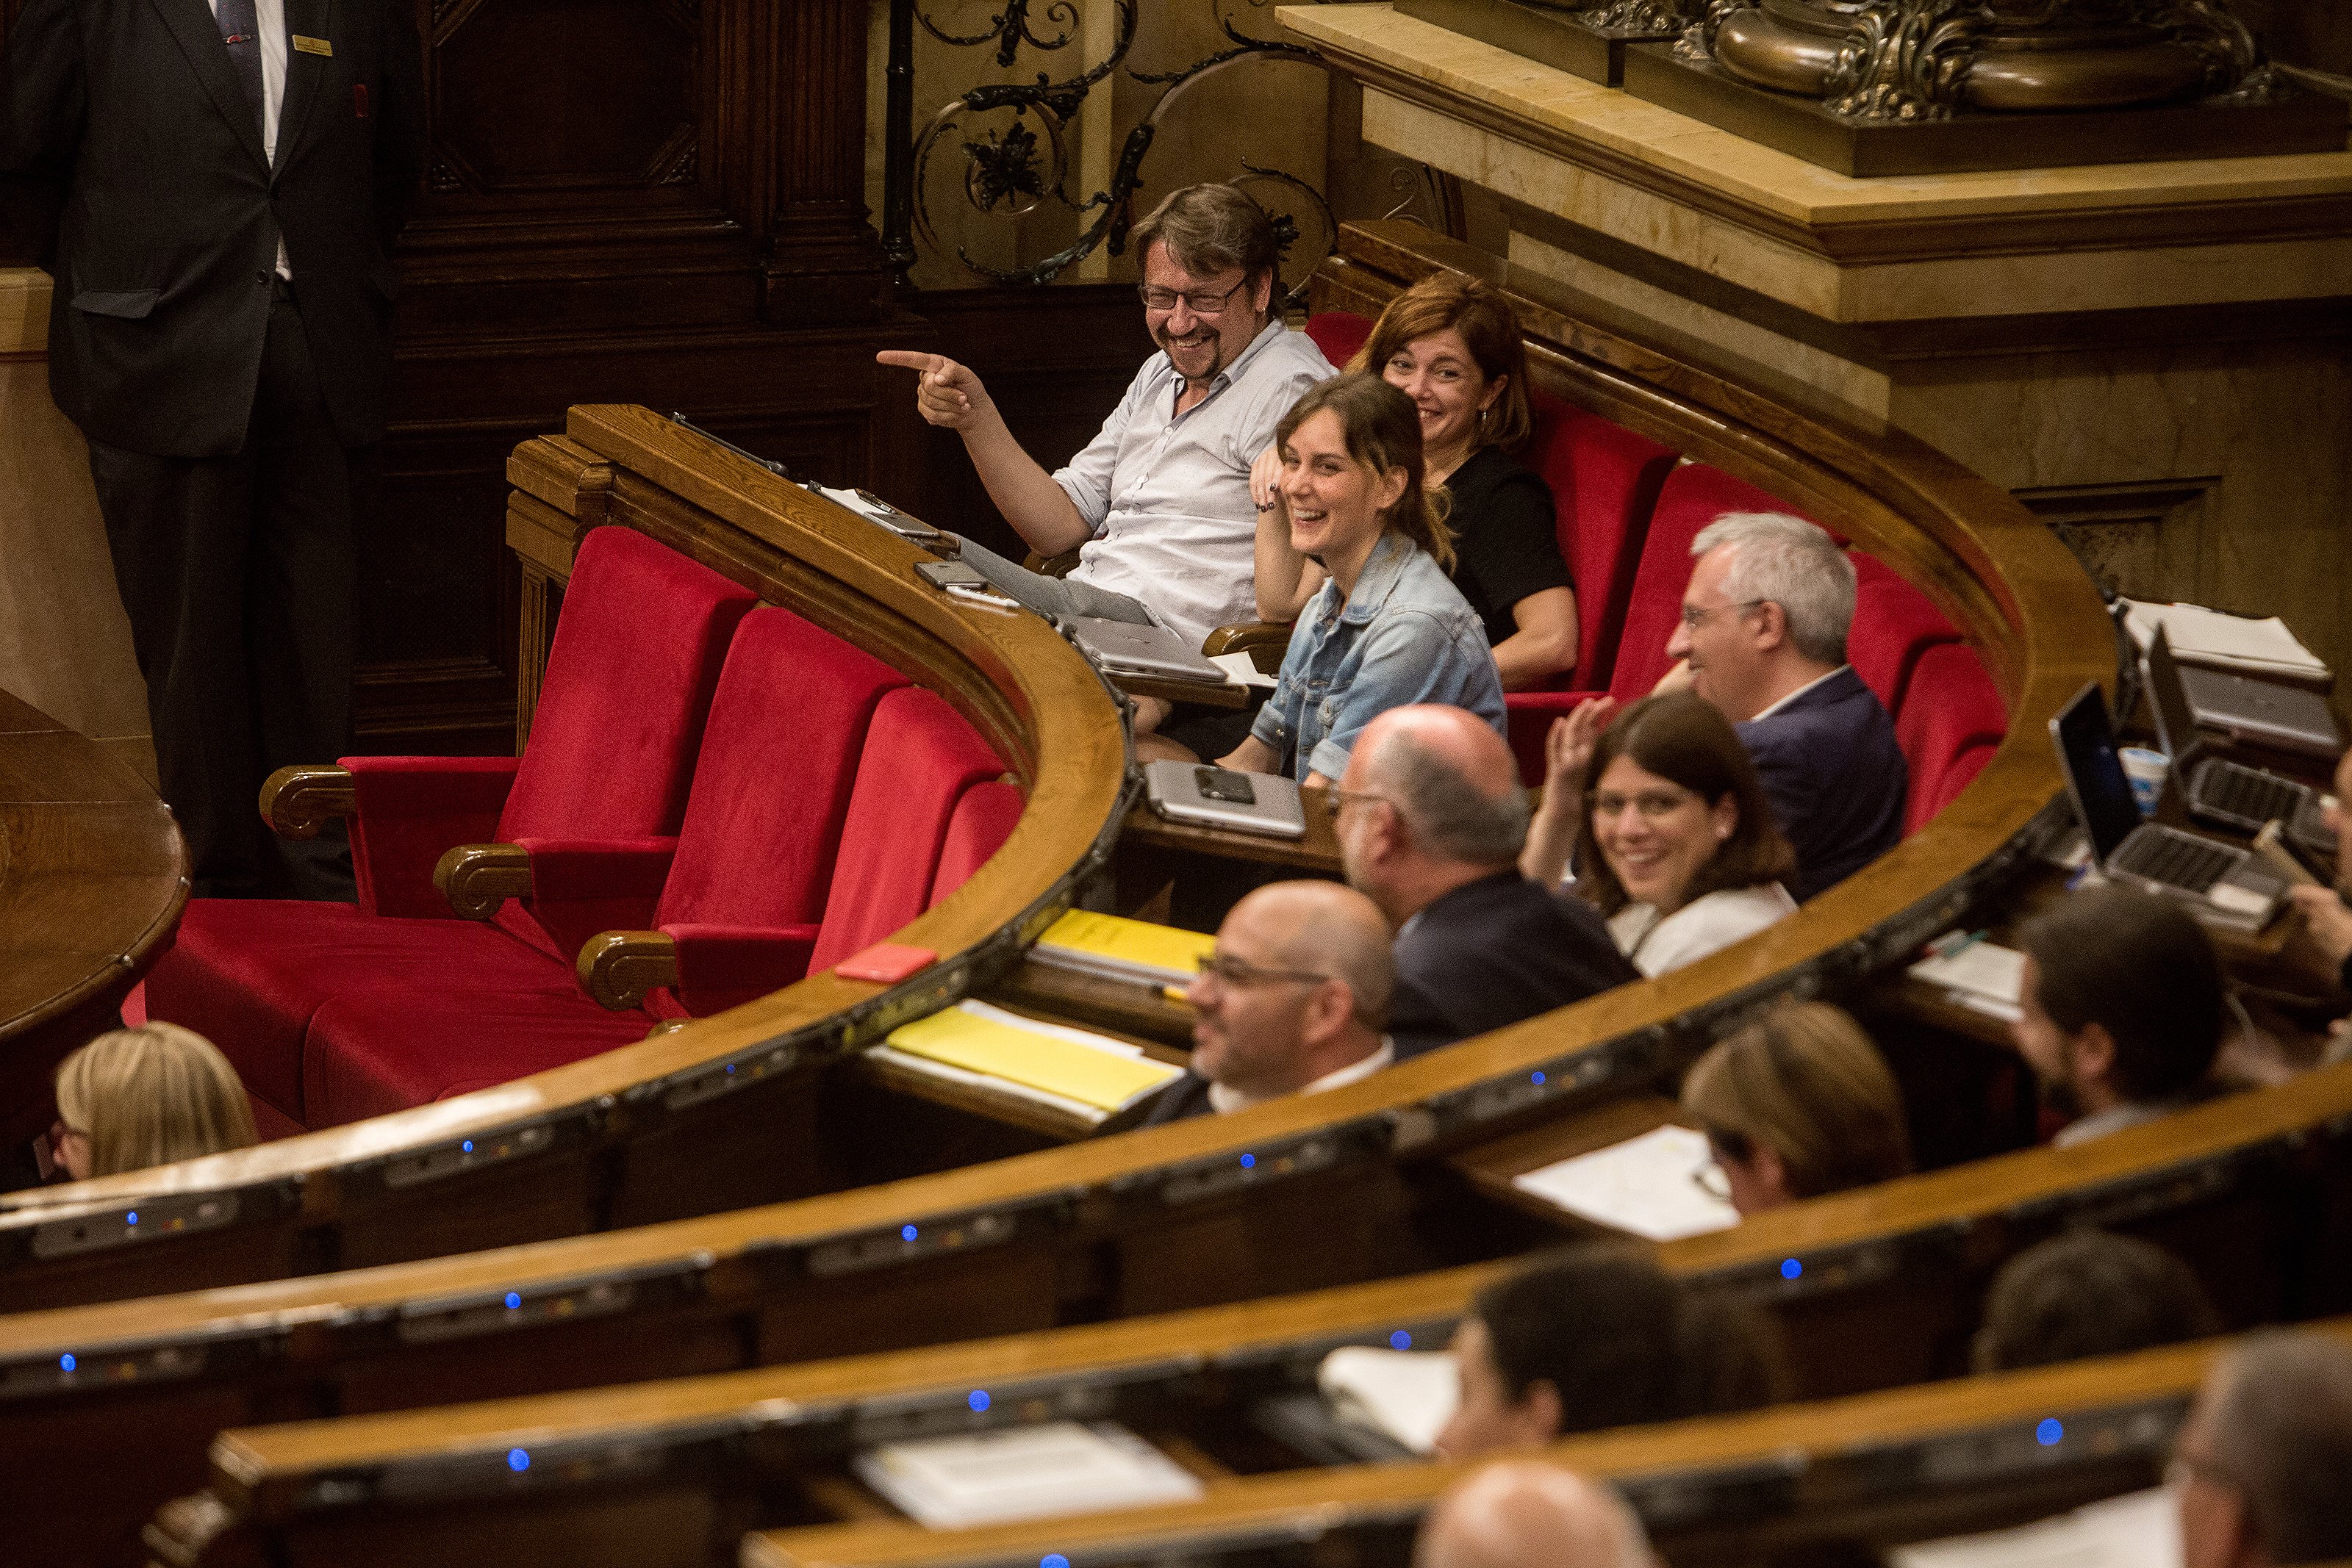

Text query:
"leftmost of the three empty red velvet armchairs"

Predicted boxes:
[[146, 527, 753, 1126]]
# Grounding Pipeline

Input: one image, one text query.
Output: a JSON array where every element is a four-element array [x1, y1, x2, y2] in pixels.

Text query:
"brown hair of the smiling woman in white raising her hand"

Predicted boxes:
[[1576, 691, 1797, 915]]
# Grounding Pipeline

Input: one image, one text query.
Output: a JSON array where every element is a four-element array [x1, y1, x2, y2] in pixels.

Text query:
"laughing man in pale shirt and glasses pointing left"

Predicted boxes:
[[875, 184, 1331, 647]]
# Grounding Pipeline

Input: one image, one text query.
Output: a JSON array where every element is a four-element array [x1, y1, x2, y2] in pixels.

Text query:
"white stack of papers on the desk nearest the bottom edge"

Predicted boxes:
[[851, 1420, 1202, 1531]]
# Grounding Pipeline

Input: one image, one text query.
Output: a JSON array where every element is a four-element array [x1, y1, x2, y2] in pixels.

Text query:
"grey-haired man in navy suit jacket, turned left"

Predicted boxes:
[[1666, 512, 1910, 900]]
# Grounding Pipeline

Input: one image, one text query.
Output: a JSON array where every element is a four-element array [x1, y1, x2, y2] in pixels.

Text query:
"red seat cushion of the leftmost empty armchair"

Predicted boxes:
[[146, 898, 576, 1126]]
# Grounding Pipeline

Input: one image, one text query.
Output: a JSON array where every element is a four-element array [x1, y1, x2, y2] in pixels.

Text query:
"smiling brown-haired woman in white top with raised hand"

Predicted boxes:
[[1519, 691, 1797, 976]]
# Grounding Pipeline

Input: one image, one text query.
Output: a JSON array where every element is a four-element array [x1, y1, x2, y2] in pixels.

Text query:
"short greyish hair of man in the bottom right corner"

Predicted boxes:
[[2206, 1331, 2352, 1564]]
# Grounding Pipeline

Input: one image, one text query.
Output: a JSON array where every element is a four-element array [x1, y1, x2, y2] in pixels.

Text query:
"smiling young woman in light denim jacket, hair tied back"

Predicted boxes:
[[1221, 374, 1503, 785]]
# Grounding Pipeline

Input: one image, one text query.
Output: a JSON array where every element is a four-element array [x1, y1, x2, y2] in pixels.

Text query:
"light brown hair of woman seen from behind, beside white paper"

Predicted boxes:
[[1682, 1001, 1912, 1199]]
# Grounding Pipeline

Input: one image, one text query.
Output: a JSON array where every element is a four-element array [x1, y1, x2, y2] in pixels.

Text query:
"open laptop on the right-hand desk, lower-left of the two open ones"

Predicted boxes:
[[2051, 682, 2286, 931]]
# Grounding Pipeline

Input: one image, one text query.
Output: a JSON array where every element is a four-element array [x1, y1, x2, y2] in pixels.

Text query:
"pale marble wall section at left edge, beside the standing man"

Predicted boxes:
[[0, 268, 155, 783]]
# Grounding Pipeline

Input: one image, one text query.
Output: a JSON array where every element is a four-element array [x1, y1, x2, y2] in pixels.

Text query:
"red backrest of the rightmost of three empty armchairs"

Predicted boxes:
[[809, 686, 1004, 974]]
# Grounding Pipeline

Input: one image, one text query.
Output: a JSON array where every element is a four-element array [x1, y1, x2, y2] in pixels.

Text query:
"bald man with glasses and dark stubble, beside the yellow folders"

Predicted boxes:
[[1145, 882, 1397, 1126]]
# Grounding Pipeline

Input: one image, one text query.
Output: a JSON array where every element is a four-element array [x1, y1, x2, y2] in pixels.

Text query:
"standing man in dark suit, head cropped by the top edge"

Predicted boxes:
[[0, 0, 423, 896]]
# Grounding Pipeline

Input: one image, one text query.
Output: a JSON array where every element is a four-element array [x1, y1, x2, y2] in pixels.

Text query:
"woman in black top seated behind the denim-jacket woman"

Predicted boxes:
[[1251, 273, 1576, 691]]
